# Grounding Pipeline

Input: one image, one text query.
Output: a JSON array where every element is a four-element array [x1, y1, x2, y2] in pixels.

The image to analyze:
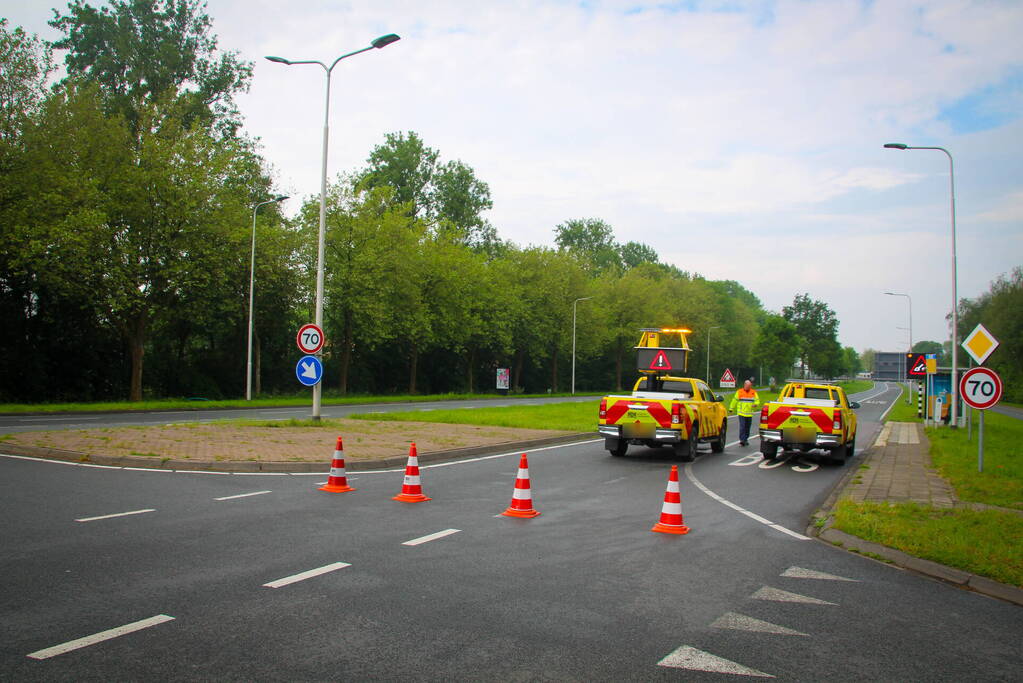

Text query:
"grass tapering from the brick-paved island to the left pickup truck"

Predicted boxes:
[[349, 399, 599, 432]]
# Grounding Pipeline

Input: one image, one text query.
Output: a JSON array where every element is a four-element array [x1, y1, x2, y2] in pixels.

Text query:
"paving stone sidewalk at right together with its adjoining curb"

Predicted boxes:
[[807, 422, 1023, 606]]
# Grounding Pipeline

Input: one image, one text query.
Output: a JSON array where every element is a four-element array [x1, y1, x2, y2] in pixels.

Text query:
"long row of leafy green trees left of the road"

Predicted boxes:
[[0, 0, 859, 402]]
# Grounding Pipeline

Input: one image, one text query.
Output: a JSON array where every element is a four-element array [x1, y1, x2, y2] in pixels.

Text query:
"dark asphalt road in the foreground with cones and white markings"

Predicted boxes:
[[0, 385, 1023, 681]]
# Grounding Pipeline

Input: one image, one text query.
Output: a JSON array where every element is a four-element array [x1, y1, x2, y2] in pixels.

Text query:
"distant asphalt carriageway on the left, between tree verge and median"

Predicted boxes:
[[0, 396, 599, 434]]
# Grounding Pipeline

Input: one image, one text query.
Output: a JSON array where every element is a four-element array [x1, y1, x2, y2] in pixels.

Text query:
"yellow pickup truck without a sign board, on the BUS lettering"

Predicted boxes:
[[760, 381, 859, 462]]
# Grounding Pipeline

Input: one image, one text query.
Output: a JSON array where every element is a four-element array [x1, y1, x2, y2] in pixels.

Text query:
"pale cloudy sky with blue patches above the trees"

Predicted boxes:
[[0, 0, 1023, 351]]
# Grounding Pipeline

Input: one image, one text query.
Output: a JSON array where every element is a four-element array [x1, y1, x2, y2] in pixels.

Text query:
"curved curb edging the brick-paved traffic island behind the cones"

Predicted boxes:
[[0, 431, 594, 476]]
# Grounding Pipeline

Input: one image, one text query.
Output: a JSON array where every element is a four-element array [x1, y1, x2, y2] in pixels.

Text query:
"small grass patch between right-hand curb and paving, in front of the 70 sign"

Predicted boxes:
[[835, 500, 1023, 587]]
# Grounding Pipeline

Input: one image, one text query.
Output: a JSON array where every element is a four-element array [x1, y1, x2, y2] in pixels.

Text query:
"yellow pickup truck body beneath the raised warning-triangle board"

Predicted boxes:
[[597, 374, 728, 462]]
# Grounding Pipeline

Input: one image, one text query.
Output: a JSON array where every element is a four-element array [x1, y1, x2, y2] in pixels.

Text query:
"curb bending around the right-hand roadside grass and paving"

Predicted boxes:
[[806, 446, 1023, 607]]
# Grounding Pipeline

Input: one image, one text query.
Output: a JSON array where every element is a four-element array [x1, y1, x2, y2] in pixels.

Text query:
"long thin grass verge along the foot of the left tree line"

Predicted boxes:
[[0, 392, 596, 413]]
